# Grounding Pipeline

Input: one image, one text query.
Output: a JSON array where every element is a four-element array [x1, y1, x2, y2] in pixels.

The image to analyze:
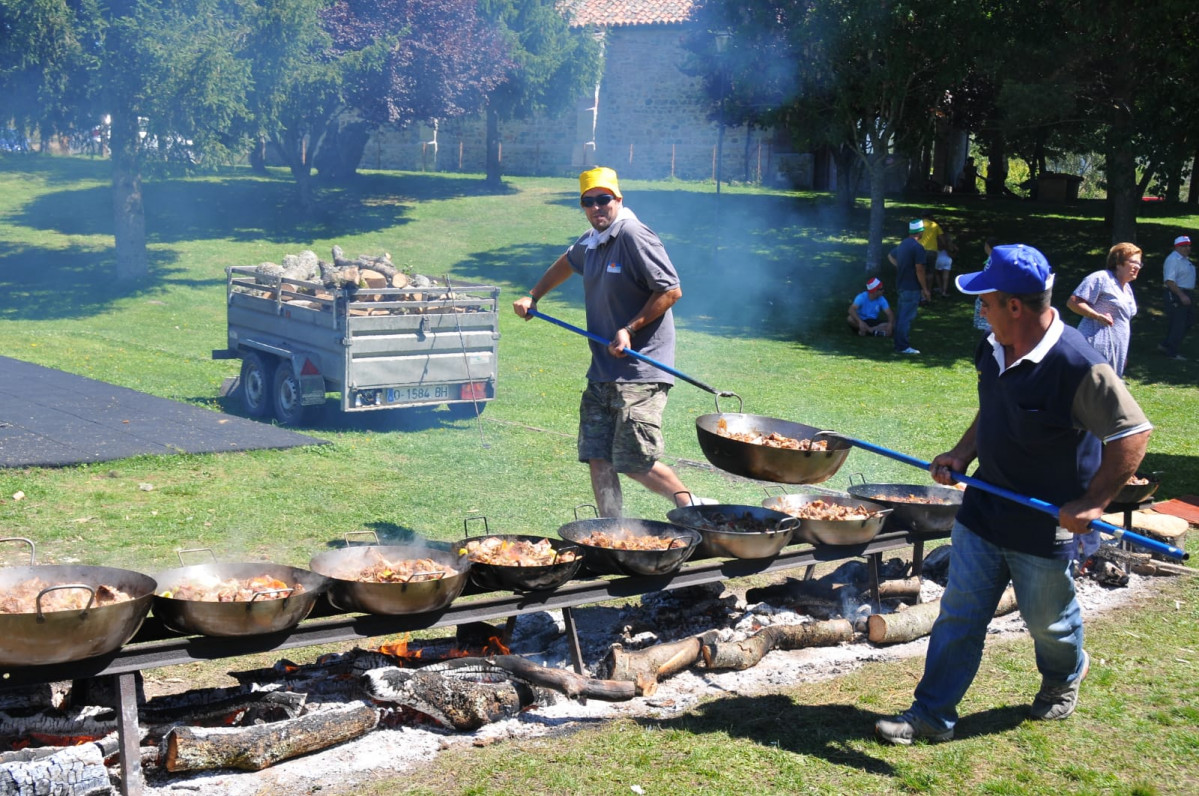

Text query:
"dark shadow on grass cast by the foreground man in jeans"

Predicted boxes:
[[638, 694, 1028, 777]]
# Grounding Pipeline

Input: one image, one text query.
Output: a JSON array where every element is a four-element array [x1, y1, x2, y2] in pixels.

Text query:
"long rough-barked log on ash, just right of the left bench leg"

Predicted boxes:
[[163, 704, 379, 772]]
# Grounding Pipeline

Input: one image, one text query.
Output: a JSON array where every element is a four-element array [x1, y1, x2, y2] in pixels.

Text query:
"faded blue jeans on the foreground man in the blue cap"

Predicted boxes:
[[911, 523, 1083, 729]]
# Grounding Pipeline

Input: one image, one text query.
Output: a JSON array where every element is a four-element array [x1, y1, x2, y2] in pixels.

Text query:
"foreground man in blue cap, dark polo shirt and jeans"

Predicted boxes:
[[874, 243, 1152, 744]]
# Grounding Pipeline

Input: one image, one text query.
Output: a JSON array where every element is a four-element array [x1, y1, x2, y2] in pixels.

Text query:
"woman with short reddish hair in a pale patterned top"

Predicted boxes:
[[1066, 243, 1141, 379]]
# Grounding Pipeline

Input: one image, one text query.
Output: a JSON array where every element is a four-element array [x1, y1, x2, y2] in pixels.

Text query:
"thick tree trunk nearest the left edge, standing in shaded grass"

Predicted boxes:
[[112, 109, 150, 284]]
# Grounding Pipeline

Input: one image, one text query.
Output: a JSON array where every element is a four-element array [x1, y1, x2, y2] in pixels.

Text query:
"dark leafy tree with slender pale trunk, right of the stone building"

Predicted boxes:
[[693, 0, 976, 271]]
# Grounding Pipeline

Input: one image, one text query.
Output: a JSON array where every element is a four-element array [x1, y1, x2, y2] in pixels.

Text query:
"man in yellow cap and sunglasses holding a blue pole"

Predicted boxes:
[[512, 168, 707, 517]]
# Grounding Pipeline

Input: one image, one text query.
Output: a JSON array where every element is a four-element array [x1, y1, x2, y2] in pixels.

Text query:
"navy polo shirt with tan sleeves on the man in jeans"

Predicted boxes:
[[958, 310, 1152, 557]]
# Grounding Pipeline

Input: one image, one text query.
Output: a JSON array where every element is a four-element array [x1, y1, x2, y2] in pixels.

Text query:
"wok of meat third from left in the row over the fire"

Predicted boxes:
[[308, 535, 470, 615]]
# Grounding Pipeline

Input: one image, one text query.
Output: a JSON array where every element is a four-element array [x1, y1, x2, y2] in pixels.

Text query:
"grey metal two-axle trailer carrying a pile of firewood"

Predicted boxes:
[[212, 266, 500, 426]]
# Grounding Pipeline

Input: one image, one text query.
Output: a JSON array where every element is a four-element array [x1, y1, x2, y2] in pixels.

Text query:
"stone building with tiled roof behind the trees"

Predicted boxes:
[[360, 0, 805, 183]]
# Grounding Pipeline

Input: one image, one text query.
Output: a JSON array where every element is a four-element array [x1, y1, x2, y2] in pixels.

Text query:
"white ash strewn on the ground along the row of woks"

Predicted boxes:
[[145, 565, 1152, 796]]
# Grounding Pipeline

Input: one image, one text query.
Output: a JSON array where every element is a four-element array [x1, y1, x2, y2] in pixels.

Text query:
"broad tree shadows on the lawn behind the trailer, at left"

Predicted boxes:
[[0, 157, 513, 320]]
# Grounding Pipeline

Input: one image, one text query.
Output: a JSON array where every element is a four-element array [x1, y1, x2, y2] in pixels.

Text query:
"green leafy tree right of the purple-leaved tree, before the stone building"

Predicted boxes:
[[478, 0, 602, 187]]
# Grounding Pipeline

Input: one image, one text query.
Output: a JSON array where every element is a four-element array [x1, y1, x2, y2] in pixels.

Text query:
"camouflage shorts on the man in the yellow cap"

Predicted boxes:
[[579, 381, 670, 472]]
